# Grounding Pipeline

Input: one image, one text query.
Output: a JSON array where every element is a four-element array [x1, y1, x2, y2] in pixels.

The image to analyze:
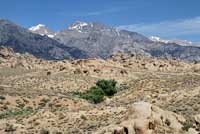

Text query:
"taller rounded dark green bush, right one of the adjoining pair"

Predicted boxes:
[[96, 80, 117, 96]]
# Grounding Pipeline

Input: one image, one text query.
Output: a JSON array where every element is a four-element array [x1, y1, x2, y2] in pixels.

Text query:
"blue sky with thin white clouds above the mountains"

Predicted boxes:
[[0, 0, 200, 42]]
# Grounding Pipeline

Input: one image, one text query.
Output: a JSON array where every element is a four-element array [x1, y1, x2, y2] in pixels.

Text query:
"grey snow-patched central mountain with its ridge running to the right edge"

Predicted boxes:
[[39, 21, 200, 61]]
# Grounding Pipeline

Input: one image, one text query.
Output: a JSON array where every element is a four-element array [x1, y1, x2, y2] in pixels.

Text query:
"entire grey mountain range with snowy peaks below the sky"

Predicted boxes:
[[0, 20, 200, 61]]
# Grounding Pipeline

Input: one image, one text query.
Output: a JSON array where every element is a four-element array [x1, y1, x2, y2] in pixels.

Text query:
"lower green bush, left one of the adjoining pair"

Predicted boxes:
[[81, 86, 104, 104]]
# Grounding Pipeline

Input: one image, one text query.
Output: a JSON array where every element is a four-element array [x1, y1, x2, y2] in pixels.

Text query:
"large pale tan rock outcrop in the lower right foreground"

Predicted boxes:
[[103, 102, 185, 134]]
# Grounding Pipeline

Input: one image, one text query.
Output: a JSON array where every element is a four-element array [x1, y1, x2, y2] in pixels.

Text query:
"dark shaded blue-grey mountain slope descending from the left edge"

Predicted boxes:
[[0, 19, 88, 59]]
